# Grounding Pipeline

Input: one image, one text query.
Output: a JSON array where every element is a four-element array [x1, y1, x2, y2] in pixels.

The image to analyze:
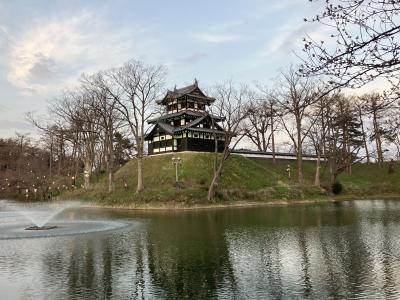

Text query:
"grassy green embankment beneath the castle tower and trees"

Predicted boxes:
[[63, 153, 400, 206]]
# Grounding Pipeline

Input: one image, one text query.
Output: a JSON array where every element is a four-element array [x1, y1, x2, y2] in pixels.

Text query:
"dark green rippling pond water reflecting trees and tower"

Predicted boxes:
[[0, 200, 400, 299]]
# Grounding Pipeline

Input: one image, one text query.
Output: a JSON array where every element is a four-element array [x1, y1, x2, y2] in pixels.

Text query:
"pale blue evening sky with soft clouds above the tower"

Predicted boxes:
[[0, 0, 388, 138]]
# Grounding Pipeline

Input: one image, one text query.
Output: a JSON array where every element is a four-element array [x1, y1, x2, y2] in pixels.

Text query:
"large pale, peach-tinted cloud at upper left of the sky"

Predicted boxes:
[[7, 11, 151, 94]]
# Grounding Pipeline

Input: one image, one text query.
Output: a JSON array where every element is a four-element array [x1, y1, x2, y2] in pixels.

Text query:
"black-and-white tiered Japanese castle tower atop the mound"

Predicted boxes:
[[145, 79, 225, 155]]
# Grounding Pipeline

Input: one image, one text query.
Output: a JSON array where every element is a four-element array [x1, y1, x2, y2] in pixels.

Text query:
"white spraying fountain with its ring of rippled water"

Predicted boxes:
[[0, 200, 128, 239]]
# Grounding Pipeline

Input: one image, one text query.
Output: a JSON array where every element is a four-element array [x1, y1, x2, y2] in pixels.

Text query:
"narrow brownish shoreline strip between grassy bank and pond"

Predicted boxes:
[[78, 194, 400, 211]]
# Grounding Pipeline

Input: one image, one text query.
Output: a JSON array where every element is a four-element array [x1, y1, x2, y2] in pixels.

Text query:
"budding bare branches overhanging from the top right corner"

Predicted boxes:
[[301, 0, 400, 93]]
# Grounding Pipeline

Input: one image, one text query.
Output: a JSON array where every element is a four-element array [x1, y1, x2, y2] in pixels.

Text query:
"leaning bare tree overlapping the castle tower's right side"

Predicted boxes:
[[207, 82, 248, 201]]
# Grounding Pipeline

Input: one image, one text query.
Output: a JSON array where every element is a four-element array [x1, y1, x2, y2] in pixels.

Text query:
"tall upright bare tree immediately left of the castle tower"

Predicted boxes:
[[106, 61, 166, 193]]
